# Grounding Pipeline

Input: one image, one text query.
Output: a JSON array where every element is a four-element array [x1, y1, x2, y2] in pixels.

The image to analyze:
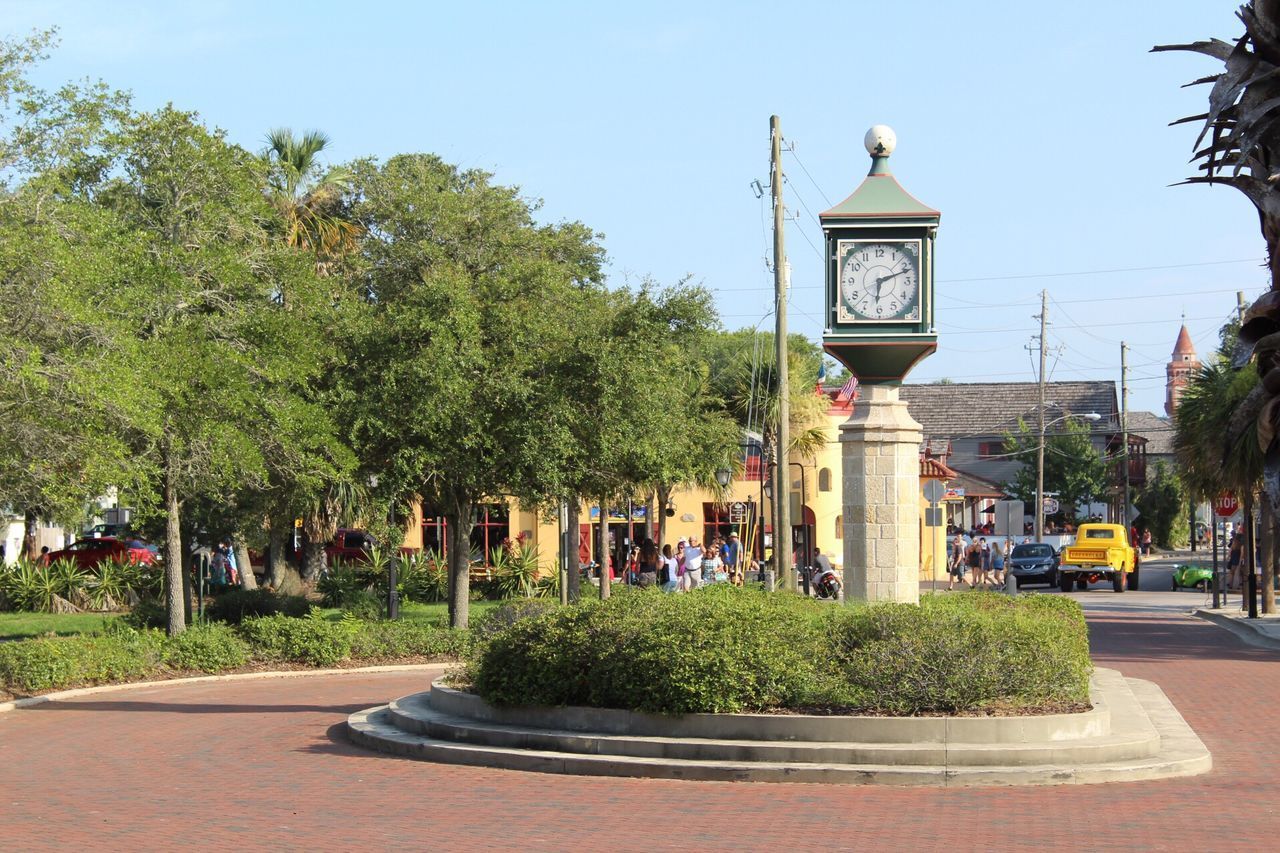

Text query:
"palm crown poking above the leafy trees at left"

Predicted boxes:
[[262, 128, 360, 261]]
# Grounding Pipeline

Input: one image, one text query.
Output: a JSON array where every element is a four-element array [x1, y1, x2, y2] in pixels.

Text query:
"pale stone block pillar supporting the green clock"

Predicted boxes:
[[840, 386, 923, 605]]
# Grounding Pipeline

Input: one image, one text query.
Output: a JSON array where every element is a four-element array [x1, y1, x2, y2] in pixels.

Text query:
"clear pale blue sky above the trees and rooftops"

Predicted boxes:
[[0, 0, 1267, 412]]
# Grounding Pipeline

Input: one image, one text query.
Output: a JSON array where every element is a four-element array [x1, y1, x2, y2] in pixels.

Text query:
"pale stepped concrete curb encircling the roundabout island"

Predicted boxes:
[[347, 669, 1212, 786]]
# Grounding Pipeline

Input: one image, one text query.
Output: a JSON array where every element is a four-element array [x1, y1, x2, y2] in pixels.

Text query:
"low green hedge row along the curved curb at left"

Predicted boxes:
[[0, 615, 470, 693]]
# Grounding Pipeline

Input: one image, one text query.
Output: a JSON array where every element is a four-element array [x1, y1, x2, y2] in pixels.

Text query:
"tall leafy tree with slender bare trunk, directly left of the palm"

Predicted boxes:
[[93, 108, 340, 634]]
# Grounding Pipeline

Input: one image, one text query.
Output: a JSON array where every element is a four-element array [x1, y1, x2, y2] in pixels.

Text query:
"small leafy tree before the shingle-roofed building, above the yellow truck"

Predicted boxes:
[[1004, 419, 1108, 507]]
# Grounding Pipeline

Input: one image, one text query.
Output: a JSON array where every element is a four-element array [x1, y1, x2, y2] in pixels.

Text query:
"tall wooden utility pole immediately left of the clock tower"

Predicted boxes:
[[769, 115, 791, 578]]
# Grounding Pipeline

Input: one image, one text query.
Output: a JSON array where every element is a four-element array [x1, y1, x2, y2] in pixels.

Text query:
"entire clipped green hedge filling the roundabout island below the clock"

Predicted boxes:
[[467, 585, 1093, 715]]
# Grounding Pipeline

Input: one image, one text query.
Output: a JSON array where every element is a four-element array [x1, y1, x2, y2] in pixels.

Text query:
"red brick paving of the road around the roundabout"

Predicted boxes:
[[0, 615, 1280, 850]]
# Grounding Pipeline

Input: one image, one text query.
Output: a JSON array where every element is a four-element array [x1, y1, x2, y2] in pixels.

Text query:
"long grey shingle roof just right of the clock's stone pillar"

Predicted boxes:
[[901, 382, 1119, 439]]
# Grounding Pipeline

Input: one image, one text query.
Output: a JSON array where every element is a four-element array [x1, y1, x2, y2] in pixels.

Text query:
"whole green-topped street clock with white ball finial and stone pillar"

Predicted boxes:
[[818, 124, 941, 603]]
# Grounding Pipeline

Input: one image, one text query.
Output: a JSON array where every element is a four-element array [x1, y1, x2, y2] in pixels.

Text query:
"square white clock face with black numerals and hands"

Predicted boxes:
[[837, 240, 920, 323]]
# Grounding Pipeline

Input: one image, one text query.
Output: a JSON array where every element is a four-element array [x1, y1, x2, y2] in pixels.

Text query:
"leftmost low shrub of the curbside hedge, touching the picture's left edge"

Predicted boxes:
[[0, 625, 163, 693]]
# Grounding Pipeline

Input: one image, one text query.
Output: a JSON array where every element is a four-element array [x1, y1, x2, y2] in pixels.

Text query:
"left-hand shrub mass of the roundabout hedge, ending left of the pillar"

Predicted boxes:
[[470, 585, 819, 713]]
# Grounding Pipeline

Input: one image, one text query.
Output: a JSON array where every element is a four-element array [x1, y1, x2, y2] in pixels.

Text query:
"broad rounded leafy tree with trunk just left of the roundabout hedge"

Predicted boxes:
[[343, 155, 602, 628]]
